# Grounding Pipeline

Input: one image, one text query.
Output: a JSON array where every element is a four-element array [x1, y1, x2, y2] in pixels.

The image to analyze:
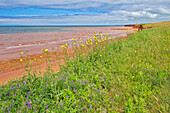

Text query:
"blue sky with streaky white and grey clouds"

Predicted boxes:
[[0, 0, 170, 26]]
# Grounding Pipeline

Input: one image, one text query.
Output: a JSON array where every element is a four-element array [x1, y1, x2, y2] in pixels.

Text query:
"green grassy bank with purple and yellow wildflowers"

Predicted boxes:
[[0, 23, 170, 113]]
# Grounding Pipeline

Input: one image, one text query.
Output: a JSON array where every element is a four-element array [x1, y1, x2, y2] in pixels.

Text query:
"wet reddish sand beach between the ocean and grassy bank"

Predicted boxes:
[[0, 27, 134, 83]]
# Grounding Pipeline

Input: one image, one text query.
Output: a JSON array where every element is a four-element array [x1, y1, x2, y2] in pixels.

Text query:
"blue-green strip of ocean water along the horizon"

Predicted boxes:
[[0, 25, 120, 34]]
